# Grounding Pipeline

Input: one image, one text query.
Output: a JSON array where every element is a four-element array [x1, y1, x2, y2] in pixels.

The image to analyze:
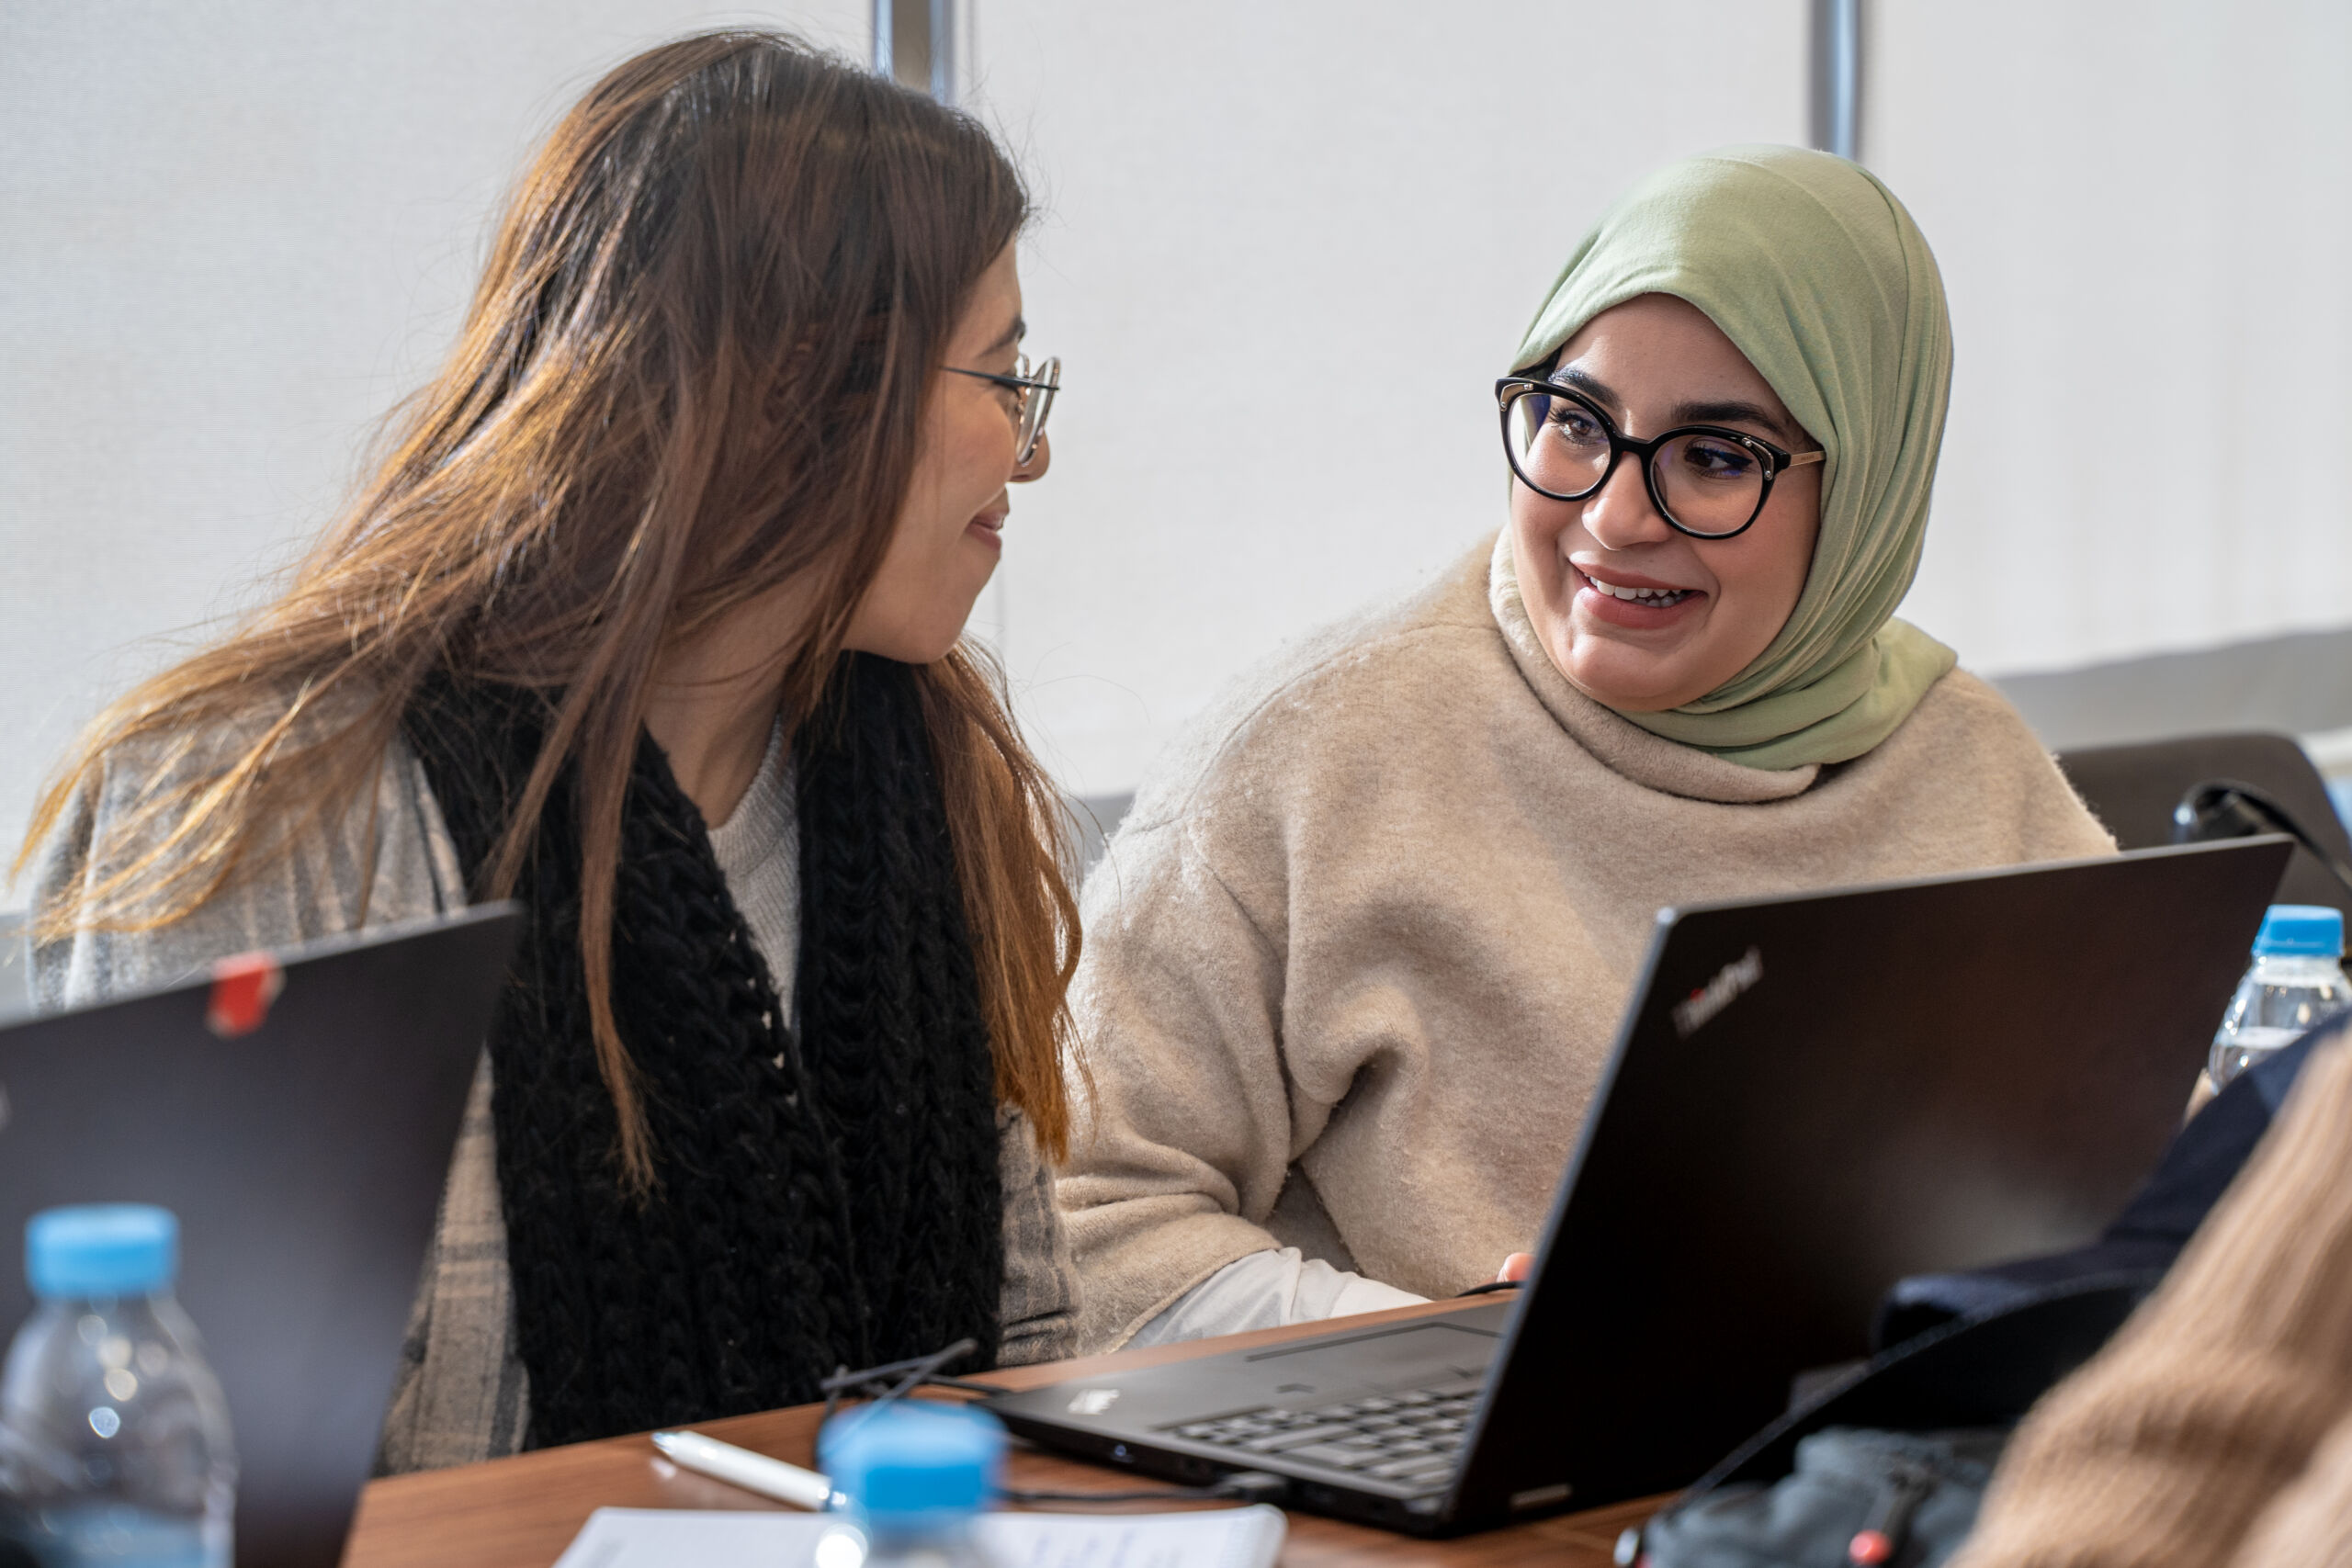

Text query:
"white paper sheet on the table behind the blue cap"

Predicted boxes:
[[555, 1502, 1284, 1568]]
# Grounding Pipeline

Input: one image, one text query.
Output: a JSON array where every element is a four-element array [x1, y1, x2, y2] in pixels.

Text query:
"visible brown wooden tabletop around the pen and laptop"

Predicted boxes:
[[344, 1303, 1663, 1568]]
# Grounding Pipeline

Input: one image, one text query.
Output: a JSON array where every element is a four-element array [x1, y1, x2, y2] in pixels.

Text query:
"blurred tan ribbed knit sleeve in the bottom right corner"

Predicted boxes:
[[1952, 1024, 2352, 1568]]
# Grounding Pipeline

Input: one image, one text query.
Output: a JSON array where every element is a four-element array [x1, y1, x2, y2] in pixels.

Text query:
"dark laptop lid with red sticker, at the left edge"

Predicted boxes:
[[0, 905, 517, 1568]]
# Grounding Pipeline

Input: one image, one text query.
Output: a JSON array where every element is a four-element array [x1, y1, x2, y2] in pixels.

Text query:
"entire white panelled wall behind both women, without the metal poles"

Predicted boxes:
[[0, 0, 2352, 869]]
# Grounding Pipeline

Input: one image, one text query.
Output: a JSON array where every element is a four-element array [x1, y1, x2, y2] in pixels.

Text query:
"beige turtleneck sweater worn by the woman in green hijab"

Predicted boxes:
[[1058, 541, 2114, 1349]]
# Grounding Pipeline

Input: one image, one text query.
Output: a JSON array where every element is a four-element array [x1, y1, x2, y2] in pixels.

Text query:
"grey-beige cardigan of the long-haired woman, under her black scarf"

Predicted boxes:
[[30, 739, 1077, 1474]]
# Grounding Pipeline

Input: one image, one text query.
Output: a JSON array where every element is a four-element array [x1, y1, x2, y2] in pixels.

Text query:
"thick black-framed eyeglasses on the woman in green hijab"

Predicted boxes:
[[1494, 376, 1827, 538]]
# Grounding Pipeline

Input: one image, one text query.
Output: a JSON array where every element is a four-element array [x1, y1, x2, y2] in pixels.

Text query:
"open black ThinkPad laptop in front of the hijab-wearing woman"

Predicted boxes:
[[990, 837, 2289, 1535]]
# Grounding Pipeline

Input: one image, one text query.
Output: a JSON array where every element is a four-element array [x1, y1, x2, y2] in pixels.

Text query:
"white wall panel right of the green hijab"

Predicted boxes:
[[1863, 0, 2352, 670]]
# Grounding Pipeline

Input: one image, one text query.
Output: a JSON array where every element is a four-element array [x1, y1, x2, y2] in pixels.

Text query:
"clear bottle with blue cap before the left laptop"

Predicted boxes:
[[0, 1203, 238, 1568]]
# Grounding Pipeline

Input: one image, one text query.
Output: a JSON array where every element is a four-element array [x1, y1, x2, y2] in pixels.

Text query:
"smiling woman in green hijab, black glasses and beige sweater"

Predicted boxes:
[[1058, 148, 2112, 1347]]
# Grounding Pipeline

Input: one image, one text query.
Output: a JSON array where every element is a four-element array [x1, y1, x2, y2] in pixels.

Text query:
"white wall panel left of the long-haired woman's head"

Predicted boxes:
[[0, 0, 868, 884]]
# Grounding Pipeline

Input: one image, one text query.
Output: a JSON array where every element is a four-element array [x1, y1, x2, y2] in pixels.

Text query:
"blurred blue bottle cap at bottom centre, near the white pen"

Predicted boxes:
[[819, 1399, 1004, 1528]]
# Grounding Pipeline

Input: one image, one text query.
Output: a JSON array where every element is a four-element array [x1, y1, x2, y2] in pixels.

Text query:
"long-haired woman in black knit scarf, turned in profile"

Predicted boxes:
[[17, 30, 1077, 1470]]
